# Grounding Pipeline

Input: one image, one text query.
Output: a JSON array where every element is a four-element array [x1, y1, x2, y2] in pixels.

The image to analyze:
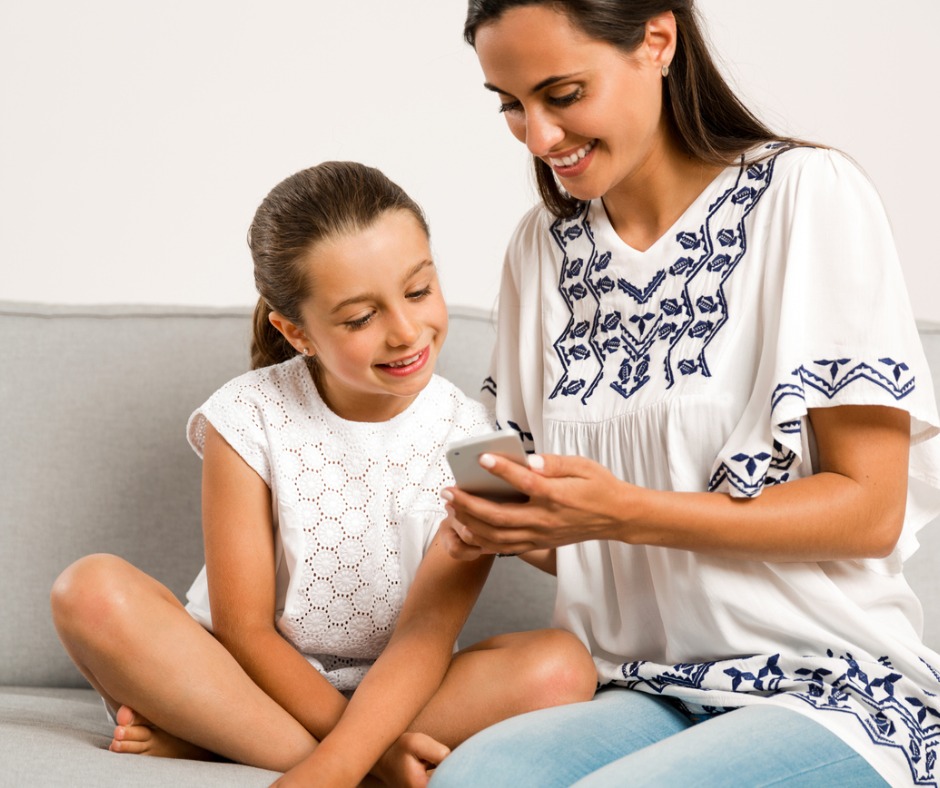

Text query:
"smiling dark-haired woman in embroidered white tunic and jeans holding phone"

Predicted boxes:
[[434, 0, 940, 786]]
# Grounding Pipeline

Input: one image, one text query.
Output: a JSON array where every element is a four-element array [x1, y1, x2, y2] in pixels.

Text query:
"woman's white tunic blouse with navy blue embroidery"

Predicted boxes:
[[488, 145, 940, 784]]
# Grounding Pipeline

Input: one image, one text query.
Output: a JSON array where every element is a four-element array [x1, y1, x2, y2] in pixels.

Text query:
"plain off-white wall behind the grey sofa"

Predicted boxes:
[[0, 0, 940, 320]]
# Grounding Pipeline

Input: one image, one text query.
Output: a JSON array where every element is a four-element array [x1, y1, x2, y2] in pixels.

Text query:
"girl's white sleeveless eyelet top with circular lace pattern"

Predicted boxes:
[[187, 357, 493, 690]]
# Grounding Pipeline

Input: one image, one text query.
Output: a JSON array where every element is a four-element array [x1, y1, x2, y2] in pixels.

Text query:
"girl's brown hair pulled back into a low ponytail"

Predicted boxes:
[[248, 161, 430, 369]]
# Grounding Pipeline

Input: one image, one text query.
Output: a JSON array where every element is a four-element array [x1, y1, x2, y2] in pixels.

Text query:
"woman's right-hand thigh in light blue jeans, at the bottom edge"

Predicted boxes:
[[571, 705, 886, 788]]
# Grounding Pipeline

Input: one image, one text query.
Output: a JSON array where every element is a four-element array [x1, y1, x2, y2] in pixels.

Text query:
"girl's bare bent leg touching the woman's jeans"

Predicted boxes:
[[412, 629, 597, 748]]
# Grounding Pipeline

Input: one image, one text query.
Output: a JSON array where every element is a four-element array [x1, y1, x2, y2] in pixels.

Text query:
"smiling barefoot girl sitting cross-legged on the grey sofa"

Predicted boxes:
[[52, 162, 596, 786]]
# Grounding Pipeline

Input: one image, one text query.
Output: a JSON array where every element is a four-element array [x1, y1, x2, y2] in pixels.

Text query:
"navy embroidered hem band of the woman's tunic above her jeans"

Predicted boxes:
[[617, 651, 940, 786]]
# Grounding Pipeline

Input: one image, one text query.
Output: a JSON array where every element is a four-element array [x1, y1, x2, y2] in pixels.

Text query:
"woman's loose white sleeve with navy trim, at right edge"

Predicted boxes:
[[709, 149, 940, 570]]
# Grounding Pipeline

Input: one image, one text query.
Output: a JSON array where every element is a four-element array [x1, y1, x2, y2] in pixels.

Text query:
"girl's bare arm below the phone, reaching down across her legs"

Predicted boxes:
[[279, 533, 492, 786]]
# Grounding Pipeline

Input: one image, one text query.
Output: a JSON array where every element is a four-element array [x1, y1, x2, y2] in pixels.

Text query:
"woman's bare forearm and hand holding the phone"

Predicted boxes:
[[448, 405, 910, 561]]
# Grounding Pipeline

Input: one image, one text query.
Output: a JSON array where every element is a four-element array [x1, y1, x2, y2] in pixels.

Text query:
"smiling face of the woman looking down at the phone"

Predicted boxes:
[[476, 5, 675, 200]]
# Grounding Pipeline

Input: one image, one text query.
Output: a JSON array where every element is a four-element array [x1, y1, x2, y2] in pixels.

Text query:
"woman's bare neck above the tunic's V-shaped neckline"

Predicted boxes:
[[603, 130, 724, 252]]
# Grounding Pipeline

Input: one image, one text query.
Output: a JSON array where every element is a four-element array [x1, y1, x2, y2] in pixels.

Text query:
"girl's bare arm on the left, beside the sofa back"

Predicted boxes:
[[202, 424, 346, 740]]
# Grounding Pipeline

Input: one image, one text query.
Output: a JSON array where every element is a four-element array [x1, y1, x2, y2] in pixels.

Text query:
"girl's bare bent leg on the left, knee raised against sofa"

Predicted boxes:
[[52, 555, 316, 771]]
